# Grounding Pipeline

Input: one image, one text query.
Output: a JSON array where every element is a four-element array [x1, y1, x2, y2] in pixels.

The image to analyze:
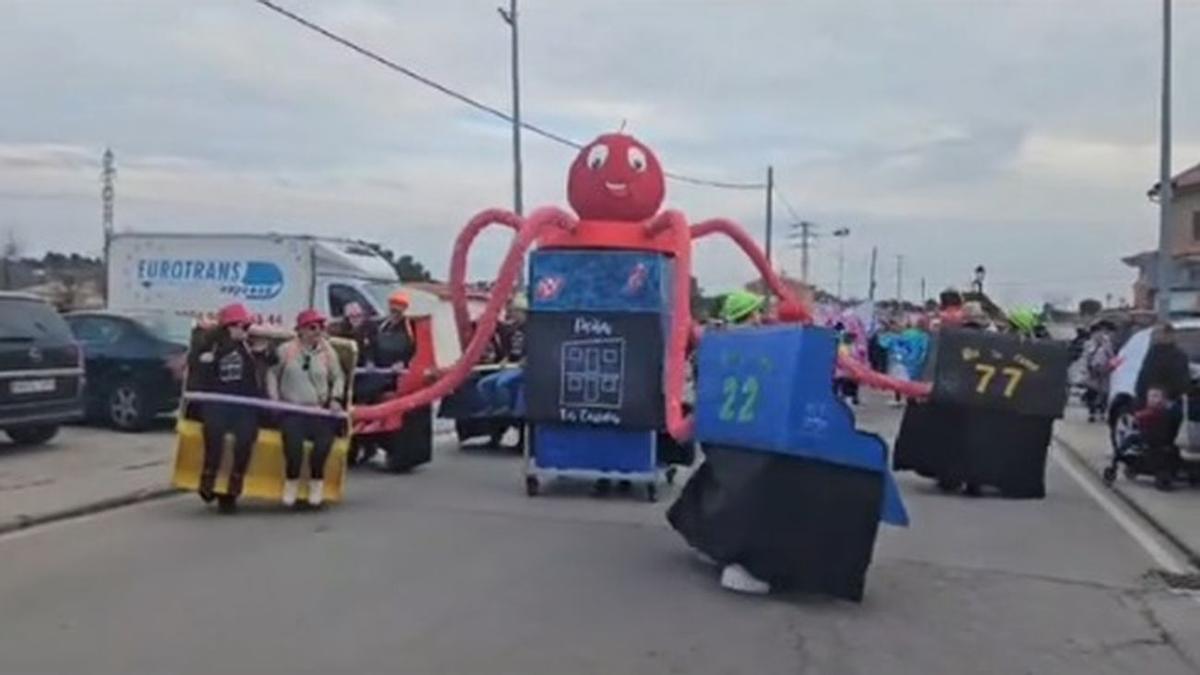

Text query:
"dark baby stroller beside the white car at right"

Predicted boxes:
[[1102, 395, 1200, 490]]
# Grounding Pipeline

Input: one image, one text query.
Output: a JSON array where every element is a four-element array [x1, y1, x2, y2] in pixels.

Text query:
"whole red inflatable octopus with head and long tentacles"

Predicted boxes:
[[354, 133, 929, 429]]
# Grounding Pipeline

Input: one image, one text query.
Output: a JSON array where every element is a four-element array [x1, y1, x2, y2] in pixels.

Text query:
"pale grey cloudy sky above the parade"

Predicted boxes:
[[0, 0, 1200, 303]]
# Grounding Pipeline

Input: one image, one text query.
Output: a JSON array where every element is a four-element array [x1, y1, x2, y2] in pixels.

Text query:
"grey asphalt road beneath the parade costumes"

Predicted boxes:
[[0, 401, 1200, 675]]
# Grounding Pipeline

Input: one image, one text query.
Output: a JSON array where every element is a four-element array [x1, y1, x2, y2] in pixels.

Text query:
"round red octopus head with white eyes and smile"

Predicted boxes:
[[566, 133, 666, 221]]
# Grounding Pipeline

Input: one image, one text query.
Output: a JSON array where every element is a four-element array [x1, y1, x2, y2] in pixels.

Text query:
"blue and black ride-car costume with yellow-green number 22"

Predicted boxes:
[[667, 325, 908, 601]]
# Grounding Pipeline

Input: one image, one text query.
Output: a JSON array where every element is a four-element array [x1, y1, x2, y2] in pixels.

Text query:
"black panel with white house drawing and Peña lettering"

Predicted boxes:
[[526, 311, 664, 429]]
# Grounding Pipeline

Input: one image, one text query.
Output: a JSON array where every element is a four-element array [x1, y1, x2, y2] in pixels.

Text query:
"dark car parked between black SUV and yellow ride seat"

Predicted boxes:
[[66, 311, 191, 431]]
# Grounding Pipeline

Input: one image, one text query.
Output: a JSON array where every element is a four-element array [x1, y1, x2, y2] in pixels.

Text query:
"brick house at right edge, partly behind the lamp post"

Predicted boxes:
[[1121, 165, 1200, 315]]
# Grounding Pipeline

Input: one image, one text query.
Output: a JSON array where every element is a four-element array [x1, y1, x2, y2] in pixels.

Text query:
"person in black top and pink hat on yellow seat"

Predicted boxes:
[[197, 304, 266, 513]]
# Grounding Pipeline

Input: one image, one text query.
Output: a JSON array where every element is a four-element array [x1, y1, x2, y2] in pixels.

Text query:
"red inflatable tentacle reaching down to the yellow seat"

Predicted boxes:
[[353, 208, 574, 430]]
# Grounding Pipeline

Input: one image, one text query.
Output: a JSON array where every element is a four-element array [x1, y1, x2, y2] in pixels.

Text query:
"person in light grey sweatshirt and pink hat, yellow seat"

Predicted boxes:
[[268, 310, 346, 507]]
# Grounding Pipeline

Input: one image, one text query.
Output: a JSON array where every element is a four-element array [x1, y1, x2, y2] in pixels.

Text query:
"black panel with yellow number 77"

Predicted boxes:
[[932, 329, 1070, 418]]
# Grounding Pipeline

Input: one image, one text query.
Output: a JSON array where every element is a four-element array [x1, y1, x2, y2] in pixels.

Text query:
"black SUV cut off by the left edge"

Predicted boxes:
[[0, 293, 84, 444]]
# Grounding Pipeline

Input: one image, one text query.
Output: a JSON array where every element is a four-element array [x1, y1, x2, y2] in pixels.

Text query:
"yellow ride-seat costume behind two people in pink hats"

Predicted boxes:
[[170, 336, 358, 502]]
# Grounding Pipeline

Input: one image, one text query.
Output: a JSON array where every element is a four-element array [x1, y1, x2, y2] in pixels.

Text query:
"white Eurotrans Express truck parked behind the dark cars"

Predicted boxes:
[[108, 232, 461, 365]]
